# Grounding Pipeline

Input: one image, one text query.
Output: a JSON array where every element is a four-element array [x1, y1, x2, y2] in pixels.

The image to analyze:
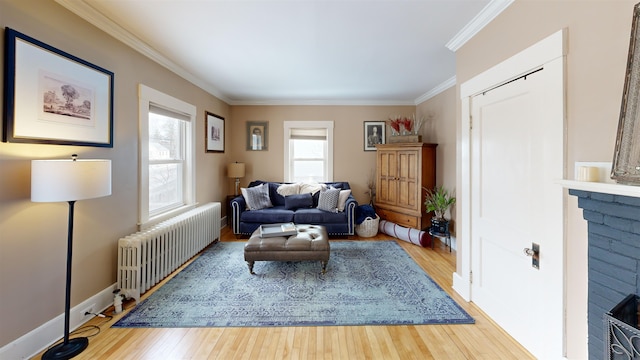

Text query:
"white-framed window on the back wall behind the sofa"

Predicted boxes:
[[284, 121, 333, 182]]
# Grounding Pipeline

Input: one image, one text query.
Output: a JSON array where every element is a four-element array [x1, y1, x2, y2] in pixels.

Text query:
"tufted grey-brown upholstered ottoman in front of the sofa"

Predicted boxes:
[[244, 225, 329, 274]]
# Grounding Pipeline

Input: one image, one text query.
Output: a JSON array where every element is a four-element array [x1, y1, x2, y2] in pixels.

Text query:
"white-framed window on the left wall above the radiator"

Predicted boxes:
[[139, 85, 196, 228]]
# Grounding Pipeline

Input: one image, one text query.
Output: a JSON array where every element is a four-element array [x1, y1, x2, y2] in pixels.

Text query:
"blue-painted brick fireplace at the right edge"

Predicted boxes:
[[569, 185, 640, 359]]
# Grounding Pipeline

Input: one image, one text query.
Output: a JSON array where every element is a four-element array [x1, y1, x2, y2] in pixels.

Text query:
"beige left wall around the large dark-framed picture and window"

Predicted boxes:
[[0, 0, 232, 347]]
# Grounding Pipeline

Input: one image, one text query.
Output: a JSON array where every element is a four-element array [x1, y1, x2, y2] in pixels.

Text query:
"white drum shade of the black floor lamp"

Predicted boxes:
[[31, 160, 111, 202]]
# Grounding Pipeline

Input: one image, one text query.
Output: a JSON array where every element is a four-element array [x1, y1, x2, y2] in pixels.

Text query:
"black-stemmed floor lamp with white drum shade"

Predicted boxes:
[[31, 155, 111, 359]]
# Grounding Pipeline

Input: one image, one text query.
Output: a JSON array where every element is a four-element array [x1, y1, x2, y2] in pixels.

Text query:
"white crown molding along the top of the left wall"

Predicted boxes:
[[55, 0, 231, 103]]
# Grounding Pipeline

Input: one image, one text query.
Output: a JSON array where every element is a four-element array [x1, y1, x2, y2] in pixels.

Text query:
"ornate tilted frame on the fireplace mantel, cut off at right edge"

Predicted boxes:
[[611, 4, 640, 185]]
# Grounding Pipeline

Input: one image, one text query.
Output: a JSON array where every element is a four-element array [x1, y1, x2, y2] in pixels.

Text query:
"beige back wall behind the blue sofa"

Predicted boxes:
[[230, 106, 416, 203]]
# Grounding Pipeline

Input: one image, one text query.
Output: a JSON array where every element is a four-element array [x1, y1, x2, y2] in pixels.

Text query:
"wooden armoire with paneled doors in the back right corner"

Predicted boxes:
[[374, 143, 438, 229]]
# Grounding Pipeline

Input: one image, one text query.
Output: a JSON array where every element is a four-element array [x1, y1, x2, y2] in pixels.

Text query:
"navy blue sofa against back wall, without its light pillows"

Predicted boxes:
[[231, 180, 358, 235]]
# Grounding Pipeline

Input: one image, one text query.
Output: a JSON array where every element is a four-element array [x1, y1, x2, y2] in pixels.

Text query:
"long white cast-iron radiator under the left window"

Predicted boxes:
[[118, 202, 221, 303]]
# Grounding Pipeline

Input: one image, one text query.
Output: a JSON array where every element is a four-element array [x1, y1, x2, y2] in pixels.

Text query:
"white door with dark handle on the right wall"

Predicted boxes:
[[470, 59, 564, 359]]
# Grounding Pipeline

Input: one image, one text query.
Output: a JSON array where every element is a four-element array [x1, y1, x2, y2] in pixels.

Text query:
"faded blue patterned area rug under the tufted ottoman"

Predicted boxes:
[[113, 241, 474, 328]]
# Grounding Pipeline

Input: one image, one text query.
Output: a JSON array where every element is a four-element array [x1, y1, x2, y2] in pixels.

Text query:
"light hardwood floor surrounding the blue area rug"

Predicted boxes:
[[34, 227, 533, 360]]
